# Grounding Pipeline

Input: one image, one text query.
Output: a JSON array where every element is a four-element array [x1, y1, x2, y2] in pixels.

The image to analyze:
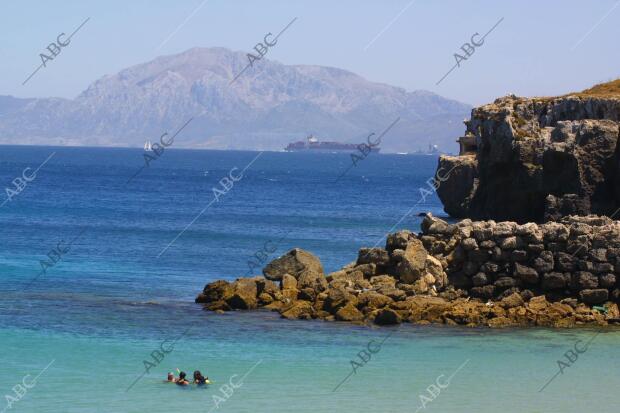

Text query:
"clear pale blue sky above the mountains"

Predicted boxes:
[[0, 0, 620, 105]]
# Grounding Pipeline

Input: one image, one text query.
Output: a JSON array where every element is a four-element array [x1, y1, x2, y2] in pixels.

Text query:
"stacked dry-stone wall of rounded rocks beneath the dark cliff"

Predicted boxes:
[[419, 212, 620, 304]]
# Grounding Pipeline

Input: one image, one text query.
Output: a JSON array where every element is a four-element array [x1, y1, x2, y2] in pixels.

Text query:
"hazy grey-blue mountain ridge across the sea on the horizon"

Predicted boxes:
[[0, 48, 471, 152]]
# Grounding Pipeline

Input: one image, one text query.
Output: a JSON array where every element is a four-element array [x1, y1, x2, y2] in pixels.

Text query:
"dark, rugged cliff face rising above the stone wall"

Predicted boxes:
[[437, 94, 620, 223]]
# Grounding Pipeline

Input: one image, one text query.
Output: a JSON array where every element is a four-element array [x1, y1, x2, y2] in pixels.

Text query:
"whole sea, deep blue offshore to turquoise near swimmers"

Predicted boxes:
[[0, 146, 620, 413]]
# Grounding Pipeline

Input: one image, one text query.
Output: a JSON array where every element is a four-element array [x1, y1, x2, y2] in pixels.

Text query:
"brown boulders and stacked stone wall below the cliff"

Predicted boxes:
[[196, 214, 620, 327]]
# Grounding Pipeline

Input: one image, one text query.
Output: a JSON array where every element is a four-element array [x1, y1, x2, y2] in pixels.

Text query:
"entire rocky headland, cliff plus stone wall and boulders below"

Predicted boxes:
[[196, 81, 620, 327]]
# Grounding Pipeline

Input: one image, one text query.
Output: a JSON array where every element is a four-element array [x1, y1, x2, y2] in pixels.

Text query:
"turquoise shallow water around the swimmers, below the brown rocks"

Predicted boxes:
[[0, 314, 620, 412]]
